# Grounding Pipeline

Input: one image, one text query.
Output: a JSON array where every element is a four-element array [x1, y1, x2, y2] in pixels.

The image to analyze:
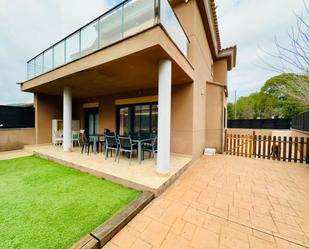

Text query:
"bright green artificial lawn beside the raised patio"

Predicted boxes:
[[0, 156, 140, 249]]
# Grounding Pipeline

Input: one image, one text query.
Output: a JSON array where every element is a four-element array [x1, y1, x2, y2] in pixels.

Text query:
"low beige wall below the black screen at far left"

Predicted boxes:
[[0, 128, 35, 151]]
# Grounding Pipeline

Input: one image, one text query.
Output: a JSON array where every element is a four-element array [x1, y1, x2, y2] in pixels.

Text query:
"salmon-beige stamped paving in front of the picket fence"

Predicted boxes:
[[104, 155, 309, 249]]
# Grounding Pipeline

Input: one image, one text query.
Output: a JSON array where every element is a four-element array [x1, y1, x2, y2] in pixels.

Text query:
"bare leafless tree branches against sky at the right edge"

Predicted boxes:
[[263, 0, 309, 105]]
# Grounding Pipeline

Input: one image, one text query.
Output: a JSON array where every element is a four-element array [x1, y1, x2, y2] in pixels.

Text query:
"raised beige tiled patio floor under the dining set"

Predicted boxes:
[[26, 145, 192, 195]]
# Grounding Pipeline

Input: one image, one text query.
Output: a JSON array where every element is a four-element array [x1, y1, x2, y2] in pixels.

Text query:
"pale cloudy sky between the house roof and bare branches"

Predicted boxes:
[[216, 0, 308, 101]]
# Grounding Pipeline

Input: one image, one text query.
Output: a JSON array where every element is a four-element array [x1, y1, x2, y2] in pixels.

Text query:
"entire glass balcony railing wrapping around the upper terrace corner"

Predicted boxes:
[[27, 0, 189, 79]]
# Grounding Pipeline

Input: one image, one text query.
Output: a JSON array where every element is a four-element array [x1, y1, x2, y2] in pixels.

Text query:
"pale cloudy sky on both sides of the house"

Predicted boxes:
[[0, 0, 309, 104]]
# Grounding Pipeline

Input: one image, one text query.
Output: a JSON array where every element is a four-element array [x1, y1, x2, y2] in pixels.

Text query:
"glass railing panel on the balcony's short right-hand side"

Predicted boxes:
[[160, 0, 188, 56]]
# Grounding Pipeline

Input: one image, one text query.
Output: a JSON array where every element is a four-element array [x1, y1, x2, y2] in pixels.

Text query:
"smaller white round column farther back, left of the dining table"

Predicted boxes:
[[63, 86, 72, 151]]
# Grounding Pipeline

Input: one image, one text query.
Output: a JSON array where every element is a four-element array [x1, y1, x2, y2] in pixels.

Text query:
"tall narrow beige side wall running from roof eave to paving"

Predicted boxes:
[[175, 0, 213, 158]]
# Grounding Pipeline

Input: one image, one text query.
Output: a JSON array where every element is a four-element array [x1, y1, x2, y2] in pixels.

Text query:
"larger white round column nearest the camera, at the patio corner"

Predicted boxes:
[[157, 60, 172, 174]]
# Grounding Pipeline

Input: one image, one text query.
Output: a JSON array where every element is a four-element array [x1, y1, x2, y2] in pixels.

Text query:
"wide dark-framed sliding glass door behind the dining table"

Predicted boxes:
[[117, 103, 158, 135]]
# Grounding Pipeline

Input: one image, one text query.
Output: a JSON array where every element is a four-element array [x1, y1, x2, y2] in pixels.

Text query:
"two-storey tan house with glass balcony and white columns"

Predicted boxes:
[[21, 0, 236, 174]]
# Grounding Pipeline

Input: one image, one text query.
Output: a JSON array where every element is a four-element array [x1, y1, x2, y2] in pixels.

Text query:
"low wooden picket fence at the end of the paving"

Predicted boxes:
[[224, 131, 309, 164]]
